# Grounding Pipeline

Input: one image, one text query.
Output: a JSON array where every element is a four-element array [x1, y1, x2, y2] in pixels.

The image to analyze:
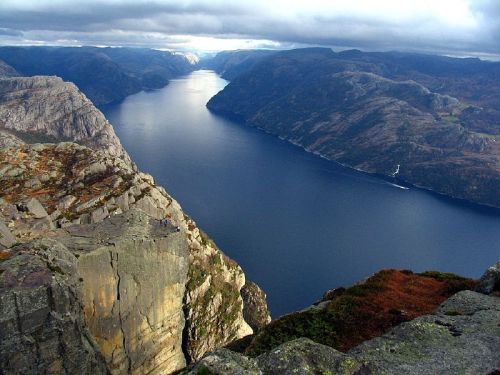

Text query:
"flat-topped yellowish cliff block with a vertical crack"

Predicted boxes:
[[59, 210, 188, 374]]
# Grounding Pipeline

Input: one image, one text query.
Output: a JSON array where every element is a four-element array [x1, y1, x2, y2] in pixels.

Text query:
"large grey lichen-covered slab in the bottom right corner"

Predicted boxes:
[[348, 291, 500, 375]]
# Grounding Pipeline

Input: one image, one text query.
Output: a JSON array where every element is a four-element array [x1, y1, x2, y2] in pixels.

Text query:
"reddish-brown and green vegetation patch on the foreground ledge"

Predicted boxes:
[[235, 270, 475, 356]]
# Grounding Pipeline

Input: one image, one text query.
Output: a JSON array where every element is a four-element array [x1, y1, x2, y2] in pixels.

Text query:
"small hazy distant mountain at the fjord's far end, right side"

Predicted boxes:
[[199, 50, 276, 81]]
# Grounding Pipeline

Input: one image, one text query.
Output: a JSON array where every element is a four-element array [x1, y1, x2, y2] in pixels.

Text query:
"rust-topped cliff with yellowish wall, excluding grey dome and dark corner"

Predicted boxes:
[[0, 143, 258, 374]]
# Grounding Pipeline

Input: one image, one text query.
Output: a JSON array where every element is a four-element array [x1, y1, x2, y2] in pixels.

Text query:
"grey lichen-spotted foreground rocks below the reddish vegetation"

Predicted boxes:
[[183, 291, 500, 375]]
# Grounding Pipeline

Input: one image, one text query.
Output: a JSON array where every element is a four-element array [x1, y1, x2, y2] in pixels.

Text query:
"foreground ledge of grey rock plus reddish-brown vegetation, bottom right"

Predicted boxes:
[[183, 263, 500, 375]]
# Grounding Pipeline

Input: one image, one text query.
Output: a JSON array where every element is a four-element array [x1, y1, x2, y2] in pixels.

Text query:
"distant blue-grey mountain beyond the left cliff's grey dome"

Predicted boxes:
[[0, 47, 195, 105]]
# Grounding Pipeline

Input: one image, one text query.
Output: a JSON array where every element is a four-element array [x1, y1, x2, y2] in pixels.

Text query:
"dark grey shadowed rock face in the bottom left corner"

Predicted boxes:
[[0, 240, 107, 375]]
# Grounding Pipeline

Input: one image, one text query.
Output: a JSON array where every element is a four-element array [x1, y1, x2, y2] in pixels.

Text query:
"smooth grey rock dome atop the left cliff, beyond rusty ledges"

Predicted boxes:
[[0, 76, 130, 161]]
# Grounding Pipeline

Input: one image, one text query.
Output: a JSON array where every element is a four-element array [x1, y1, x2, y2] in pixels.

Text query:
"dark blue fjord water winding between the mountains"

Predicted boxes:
[[102, 71, 500, 317]]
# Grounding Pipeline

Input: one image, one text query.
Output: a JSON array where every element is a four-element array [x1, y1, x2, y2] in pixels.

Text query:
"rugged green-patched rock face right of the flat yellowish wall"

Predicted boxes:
[[185, 228, 253, 361]]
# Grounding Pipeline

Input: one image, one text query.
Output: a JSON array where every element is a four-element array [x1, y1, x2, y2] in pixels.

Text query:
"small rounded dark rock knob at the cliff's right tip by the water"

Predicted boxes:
[[241, 281, 271, 332]]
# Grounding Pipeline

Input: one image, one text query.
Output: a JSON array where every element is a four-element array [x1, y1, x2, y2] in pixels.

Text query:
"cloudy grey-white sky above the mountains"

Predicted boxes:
[[0, 0, 500, 59]]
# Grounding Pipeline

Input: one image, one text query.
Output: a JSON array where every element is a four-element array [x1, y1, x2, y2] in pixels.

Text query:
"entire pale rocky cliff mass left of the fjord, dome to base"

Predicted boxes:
[[0, 76, 268, 374]]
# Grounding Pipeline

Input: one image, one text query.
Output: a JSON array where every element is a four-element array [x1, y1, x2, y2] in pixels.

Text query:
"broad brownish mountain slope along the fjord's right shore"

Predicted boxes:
[[207, 48, 500, 207]]
